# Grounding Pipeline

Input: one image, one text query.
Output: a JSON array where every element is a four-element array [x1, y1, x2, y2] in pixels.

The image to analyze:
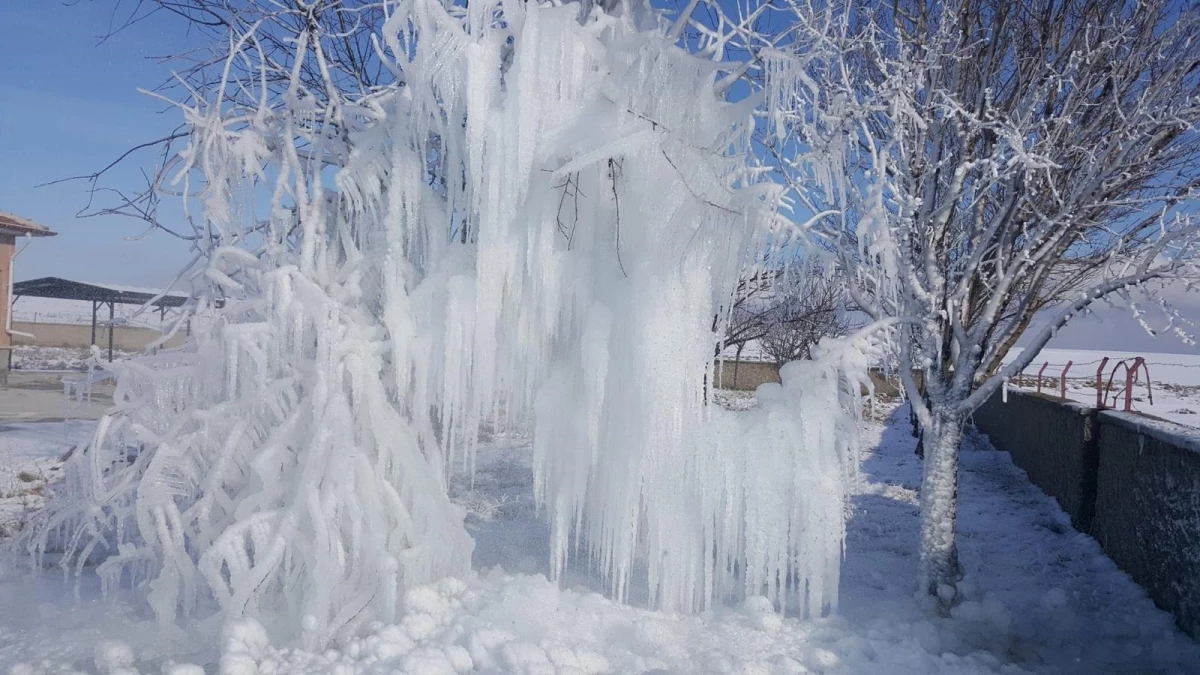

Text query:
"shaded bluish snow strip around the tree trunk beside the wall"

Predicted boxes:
[[841, 408, 1200, 673]]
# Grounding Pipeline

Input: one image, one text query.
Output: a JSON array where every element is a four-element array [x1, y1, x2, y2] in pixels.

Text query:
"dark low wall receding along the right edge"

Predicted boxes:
[[974, 392, 1200, 639]]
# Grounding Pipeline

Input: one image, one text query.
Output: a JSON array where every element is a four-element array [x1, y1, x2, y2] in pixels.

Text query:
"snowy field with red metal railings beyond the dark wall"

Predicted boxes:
[[1006, 350, 1200, 426]]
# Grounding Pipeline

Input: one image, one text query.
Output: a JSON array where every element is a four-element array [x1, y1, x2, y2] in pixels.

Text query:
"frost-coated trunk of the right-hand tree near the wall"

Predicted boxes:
[[917, 411, 966, 608]]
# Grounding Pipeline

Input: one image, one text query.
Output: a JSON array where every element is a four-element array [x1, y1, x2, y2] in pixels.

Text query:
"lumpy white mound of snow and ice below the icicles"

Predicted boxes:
[[189, 573, 1032, 675]]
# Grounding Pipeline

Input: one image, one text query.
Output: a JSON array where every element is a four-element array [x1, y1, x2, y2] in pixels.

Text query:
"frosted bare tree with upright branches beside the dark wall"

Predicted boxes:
[[761, 0, 1200, 603]]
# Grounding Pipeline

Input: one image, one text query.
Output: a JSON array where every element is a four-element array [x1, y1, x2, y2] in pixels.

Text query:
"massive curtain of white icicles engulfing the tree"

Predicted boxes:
[[29, 0, 864, 644]]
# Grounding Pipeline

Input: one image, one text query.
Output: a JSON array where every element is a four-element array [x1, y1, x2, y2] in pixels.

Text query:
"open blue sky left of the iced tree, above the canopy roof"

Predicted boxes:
[[0, 0, 194, 286]]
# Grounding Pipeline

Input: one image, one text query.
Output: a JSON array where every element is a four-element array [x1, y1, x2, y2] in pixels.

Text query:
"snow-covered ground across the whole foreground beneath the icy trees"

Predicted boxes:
[[0, 402, 1200, 675]]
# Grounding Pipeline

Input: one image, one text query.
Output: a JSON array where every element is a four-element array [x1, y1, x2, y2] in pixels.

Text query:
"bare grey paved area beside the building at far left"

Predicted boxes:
[[0, 370, 113, 424]]
